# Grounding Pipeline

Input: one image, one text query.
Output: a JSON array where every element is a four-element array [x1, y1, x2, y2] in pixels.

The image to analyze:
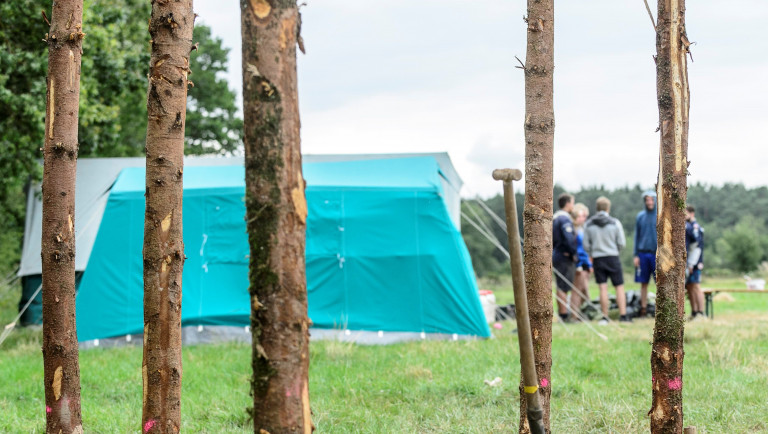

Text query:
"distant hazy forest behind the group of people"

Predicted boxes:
[[461, 184, 768, 277]]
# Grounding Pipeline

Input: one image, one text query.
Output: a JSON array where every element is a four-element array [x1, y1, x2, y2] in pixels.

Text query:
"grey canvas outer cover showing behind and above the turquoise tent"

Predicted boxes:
[[17, 152, 463, 277]]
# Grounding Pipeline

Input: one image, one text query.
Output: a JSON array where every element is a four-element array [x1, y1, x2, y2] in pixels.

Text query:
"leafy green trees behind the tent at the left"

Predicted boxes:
[[0, 0, 243, 275]]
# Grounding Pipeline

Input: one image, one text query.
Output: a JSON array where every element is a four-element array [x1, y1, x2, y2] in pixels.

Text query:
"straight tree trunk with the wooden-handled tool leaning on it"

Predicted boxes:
[[520, 0, 555, 433]]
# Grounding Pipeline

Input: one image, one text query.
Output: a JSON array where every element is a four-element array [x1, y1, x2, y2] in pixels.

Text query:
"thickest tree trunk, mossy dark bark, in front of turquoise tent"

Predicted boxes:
[[240, 0, 314, 434]]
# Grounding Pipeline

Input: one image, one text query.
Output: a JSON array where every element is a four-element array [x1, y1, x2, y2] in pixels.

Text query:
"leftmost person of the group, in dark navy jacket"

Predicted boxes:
[[552, 193, 578, 321]]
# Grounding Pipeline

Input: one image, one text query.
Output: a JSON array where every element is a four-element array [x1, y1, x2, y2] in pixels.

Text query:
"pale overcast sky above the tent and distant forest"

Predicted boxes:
[[195, 0, 768, 197]]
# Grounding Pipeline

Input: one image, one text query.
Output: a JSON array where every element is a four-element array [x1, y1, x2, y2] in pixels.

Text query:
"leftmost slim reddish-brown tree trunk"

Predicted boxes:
[[41, 0, 85, 434]]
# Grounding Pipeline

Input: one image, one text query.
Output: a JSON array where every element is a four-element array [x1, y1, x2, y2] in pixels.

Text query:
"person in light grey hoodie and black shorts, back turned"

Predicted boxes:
[[584, 196, 632, 324]]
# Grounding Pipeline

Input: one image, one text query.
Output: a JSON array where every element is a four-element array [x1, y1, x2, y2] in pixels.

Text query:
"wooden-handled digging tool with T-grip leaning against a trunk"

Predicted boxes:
[[493, 169, 545, 434]]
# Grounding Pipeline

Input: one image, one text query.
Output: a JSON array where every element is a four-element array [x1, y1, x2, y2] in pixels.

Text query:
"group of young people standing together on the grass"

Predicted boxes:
[[552, 191, 704, 324]]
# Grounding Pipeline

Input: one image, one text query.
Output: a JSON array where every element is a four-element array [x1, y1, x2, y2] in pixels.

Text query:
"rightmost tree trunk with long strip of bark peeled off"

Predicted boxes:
[[649, 0, 690, 433]]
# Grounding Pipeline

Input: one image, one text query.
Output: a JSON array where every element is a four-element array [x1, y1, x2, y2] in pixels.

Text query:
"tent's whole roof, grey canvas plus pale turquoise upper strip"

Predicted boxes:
[[18, 153, 462, 276]]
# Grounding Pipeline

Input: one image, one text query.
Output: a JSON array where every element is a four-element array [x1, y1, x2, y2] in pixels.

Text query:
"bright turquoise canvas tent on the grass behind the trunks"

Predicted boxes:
[[77, 156, 490, 341]]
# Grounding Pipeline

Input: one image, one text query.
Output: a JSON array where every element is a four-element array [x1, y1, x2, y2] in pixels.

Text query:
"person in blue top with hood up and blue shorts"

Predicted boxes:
[[633, 190, 656, 317]]
